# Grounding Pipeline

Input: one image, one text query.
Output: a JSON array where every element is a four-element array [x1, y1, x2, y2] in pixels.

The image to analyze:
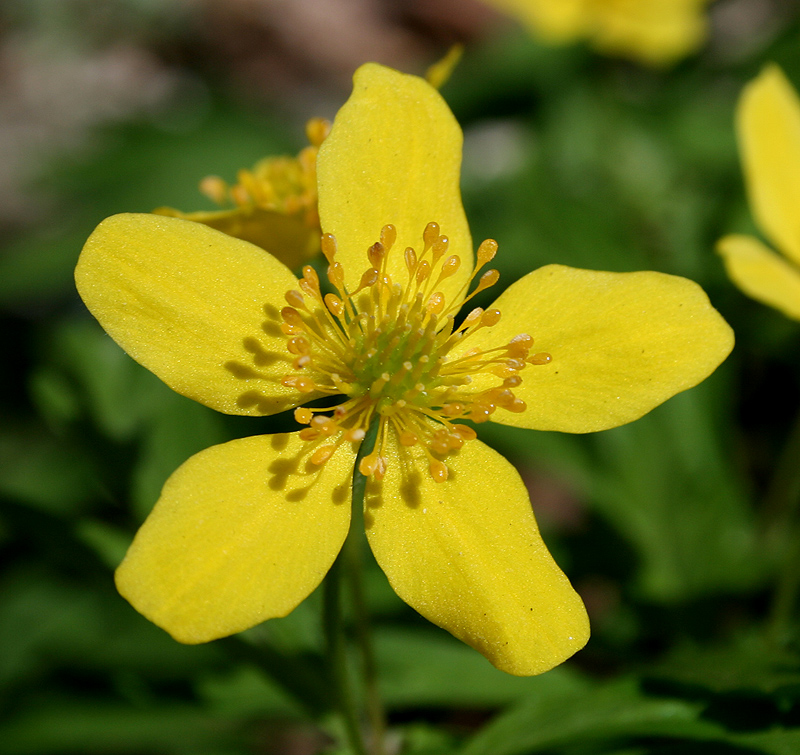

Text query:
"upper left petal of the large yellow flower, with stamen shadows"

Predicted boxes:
[[75, 214, 309, 415]]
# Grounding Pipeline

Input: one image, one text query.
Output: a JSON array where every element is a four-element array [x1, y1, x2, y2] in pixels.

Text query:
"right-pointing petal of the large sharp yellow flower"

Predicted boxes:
[[450, 265, 733, 433]]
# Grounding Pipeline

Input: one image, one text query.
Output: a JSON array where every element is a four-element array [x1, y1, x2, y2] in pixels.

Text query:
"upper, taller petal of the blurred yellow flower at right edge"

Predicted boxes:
[[736, 64, 800, 263]]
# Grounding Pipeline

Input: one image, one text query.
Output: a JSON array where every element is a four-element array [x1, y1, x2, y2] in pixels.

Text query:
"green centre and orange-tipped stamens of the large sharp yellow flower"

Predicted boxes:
[[281, 223, 551, 482]]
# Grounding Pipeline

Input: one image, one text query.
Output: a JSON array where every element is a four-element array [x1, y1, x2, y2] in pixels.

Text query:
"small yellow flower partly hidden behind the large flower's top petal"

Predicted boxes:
[[153, 118, 330, 270]]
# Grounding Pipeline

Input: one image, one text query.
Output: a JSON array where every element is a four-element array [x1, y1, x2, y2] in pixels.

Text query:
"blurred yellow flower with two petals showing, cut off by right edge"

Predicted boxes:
[[717, 64, 800, 320]]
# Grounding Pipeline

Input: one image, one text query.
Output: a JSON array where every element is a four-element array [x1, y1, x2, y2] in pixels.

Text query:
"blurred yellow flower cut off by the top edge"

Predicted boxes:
[[486, 0, 709, 66]]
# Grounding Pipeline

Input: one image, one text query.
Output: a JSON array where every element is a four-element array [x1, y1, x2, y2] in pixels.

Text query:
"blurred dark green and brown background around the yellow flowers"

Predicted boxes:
[[0, 0, 800, 755]]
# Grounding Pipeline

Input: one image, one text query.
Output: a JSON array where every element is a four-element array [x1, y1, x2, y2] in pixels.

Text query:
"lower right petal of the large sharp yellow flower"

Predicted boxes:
[[365, 433, 589, 676]]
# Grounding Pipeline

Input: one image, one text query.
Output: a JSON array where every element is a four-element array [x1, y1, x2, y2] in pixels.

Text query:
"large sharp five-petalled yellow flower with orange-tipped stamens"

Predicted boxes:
[[76, 64, 733, 675]]
